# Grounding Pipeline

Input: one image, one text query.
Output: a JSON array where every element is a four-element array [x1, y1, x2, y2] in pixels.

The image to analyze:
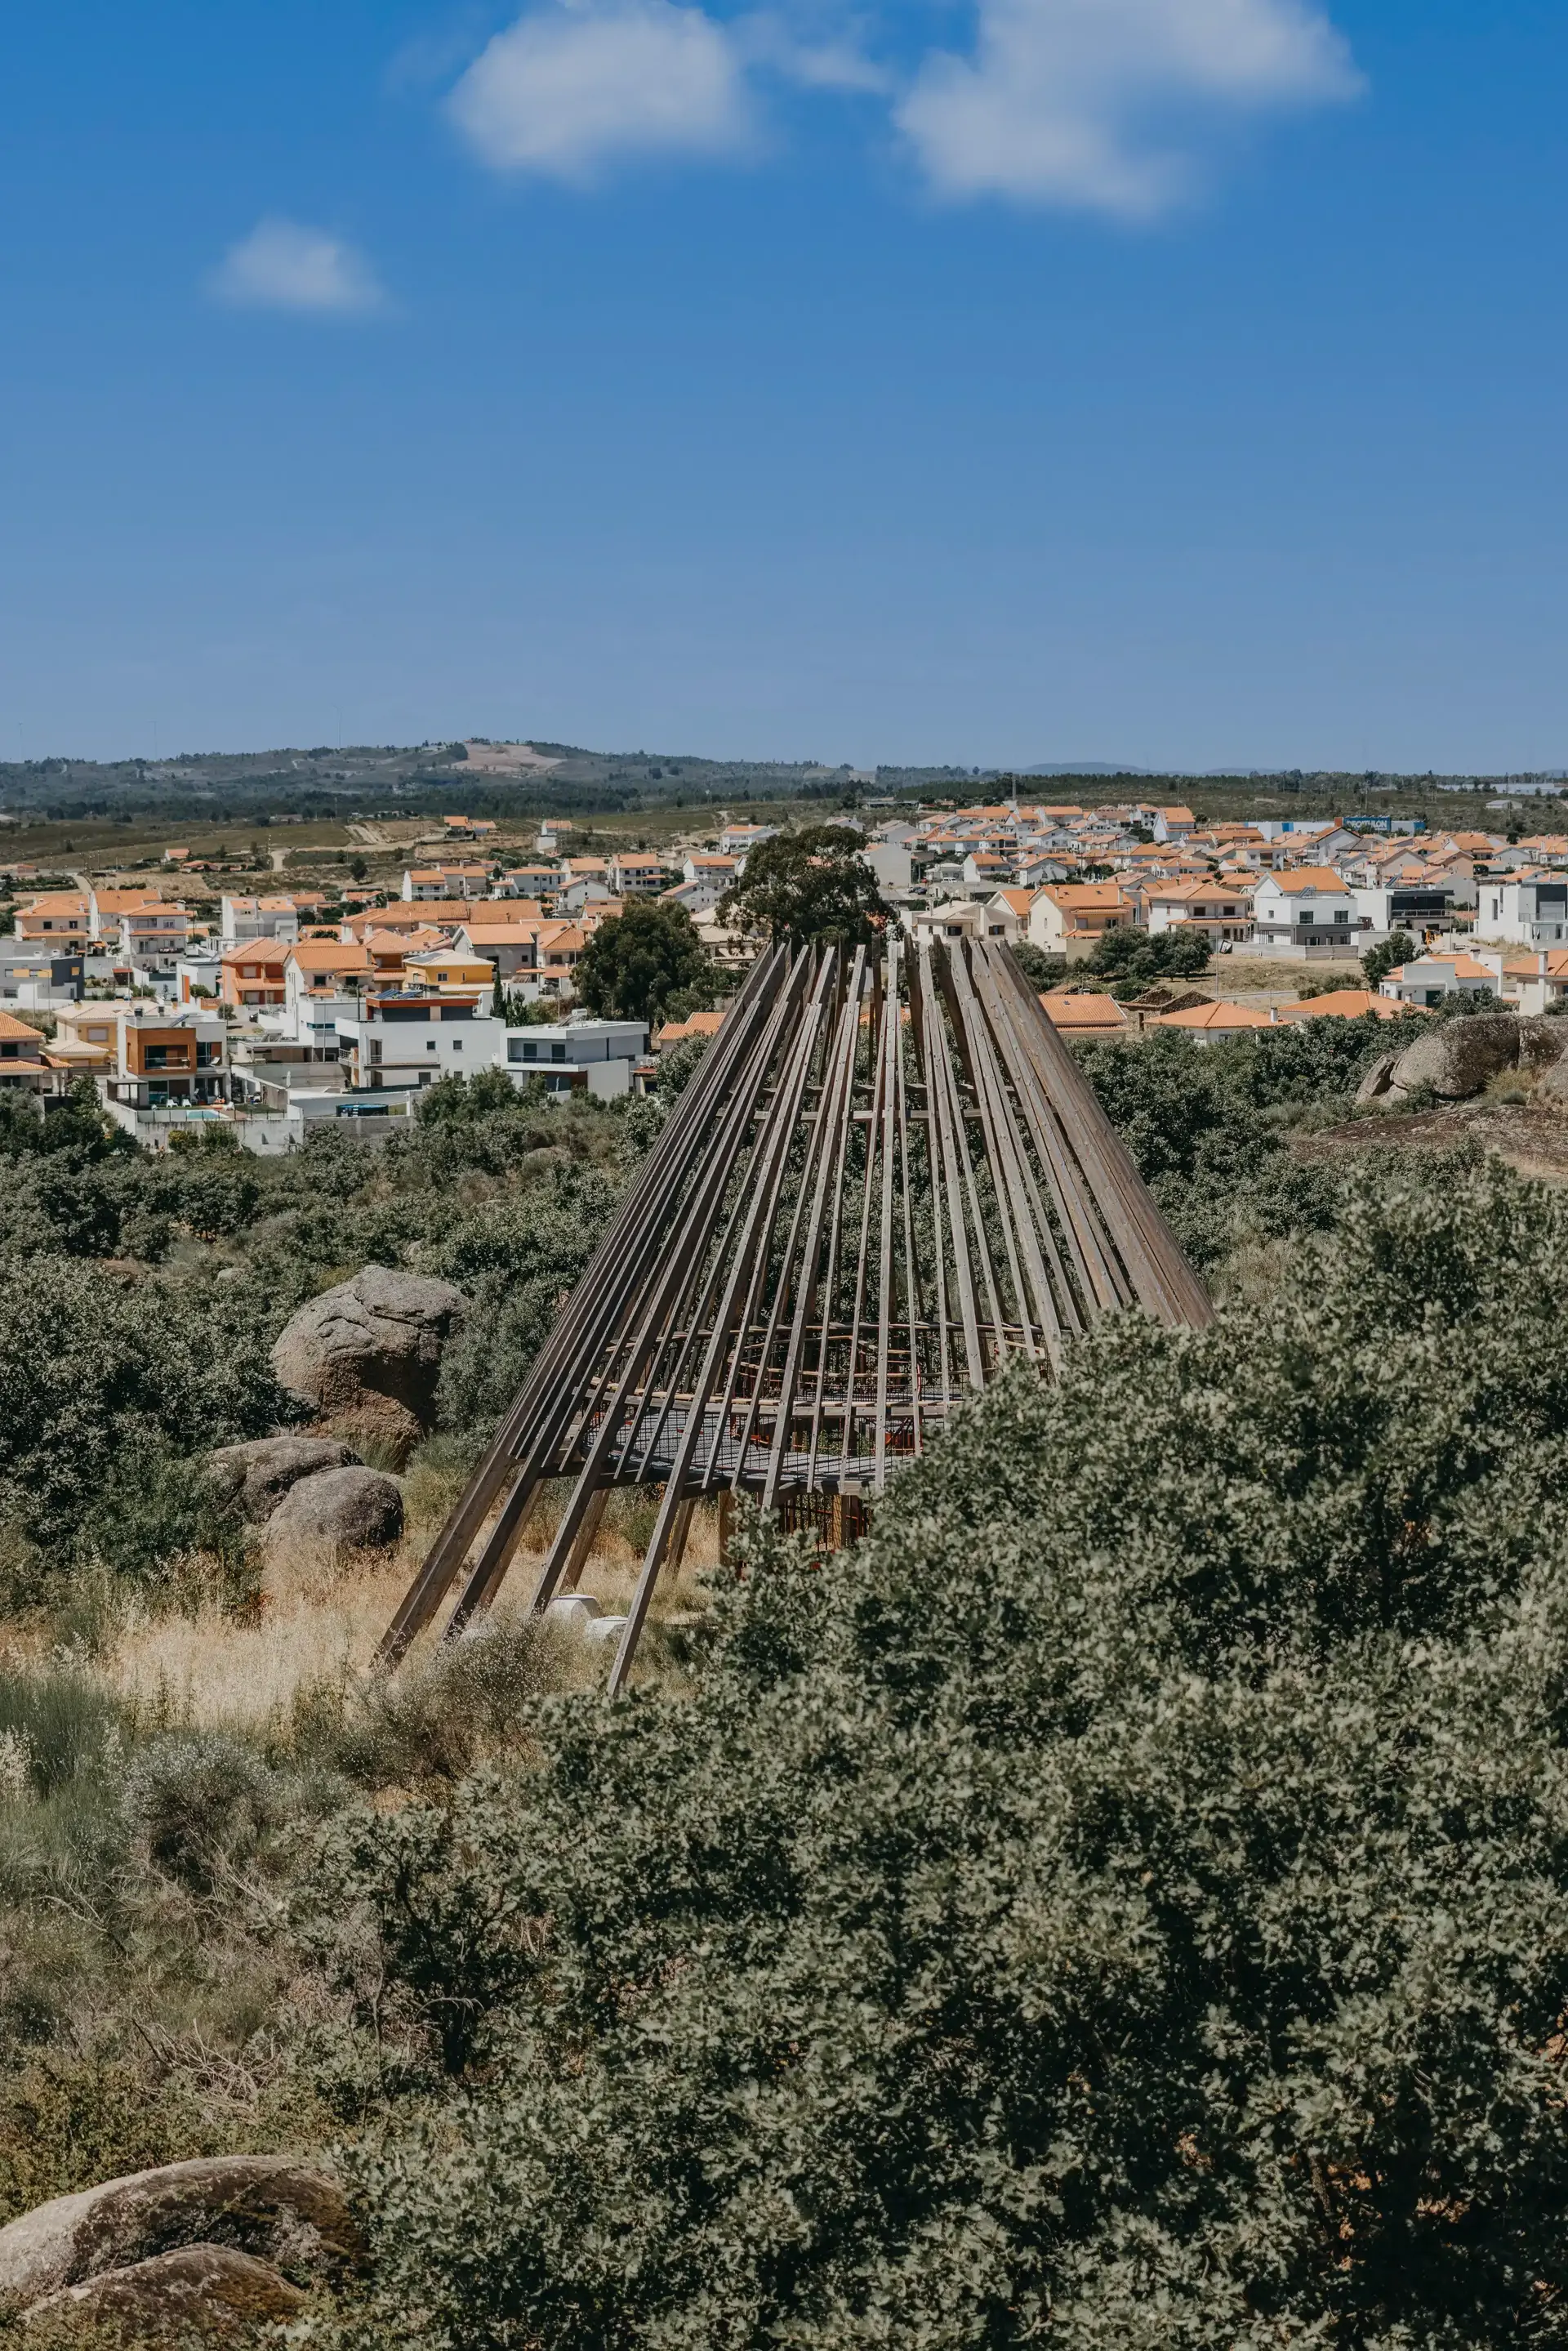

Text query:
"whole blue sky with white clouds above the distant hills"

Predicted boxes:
[[0, 0, 1568, 769]]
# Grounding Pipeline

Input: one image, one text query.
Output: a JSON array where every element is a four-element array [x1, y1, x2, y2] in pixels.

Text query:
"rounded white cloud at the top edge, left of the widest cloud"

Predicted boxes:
[[449, 0, 750, 181]]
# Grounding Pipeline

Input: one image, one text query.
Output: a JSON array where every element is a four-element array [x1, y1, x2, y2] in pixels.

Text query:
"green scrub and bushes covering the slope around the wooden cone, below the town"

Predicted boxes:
[[0, 983, 1568, 2351]]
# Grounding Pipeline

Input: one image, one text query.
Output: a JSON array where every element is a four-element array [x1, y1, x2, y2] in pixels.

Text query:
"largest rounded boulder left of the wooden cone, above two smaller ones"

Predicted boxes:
[[273, 1265, 468, 1448]]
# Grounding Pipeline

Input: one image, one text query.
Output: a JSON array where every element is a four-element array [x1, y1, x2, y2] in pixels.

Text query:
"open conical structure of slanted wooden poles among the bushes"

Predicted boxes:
[[381, 940, 1210, 1693]]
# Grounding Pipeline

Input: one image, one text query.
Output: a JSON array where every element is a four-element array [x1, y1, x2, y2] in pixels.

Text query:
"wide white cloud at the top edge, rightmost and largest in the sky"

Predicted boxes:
[[896, 0, 1361, 219]]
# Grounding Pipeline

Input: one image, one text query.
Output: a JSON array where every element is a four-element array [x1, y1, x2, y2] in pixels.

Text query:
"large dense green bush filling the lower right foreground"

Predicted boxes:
[[324, 1171, 1568, 2351]]
